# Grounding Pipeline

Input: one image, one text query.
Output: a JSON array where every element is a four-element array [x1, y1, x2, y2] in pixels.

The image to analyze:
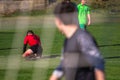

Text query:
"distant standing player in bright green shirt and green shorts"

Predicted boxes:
[[77, 0, 91, 29]]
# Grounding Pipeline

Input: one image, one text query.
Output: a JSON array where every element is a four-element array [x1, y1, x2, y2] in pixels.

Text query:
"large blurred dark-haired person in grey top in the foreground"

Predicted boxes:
[[50, 1, 105, 80]]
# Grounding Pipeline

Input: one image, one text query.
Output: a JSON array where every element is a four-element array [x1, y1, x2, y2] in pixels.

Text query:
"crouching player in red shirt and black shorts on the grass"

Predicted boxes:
[[22, 30, 43, 59]]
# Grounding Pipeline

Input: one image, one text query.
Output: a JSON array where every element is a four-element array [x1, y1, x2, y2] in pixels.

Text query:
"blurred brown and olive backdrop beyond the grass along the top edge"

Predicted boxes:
[[0, 0, 120, 16]]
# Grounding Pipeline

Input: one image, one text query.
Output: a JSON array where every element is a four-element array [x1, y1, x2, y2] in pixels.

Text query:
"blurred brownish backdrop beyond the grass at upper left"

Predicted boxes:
[[0, 0, 57, 17]]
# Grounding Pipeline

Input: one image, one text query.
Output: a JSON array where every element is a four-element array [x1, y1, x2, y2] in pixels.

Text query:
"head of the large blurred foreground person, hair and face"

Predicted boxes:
[[54, 1, 78, 33]]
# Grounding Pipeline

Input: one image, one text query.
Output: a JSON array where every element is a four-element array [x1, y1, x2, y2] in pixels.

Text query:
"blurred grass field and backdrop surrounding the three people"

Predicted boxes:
[[0, 0, 120, 80]]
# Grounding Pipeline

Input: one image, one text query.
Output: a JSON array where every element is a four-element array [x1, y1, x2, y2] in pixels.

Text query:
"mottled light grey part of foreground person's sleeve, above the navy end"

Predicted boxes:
[[77, 33, 100, 57]]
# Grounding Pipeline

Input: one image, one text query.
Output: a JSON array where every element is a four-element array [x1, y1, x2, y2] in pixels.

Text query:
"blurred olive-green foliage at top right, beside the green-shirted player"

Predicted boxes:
[[72, 0, 120, 12]]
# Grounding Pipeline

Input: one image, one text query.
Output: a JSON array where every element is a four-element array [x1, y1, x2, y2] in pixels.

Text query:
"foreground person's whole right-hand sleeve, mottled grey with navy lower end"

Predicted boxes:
[[77, 33, 104, 68]]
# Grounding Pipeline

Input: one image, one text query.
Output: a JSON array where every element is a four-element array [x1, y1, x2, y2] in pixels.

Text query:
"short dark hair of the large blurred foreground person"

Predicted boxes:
[[54, 1, 78, 25]]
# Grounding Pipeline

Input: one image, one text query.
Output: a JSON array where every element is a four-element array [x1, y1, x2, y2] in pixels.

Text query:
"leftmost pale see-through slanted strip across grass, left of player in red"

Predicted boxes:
[[4, 0, 29, 80]]
